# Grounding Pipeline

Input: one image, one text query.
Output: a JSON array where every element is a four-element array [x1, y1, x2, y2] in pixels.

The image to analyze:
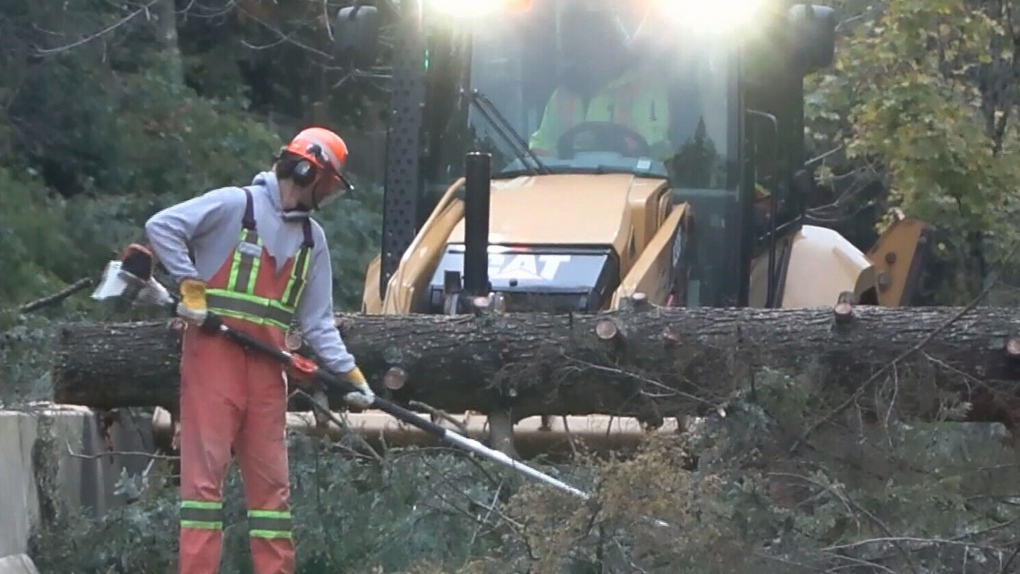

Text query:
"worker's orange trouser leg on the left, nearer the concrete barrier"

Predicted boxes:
[[177, 328, 247, 574]]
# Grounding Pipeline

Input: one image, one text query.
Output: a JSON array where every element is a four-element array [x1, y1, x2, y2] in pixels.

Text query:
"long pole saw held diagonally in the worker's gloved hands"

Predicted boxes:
[[92, 244, 592, 501]]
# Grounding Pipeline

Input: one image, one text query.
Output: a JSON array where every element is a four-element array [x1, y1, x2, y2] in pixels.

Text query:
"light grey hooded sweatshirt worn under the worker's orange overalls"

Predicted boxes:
[[145, 171, 355, 373]]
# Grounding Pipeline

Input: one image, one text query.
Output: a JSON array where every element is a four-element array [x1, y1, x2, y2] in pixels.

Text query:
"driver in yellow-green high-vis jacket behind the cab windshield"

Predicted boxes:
[[529, 3, 672, 159]]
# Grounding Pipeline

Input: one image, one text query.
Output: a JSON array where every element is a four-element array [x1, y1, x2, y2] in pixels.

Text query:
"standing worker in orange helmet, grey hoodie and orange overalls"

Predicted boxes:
[[145, 127, 374, 574]]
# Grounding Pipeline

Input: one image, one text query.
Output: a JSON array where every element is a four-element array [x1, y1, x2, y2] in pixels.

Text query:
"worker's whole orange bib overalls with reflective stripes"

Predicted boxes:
[[177, 189, 313, 574]]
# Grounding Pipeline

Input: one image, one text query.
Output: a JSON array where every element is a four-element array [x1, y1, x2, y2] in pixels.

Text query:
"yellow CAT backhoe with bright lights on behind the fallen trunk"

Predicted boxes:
[[336, 0, 925, 314]]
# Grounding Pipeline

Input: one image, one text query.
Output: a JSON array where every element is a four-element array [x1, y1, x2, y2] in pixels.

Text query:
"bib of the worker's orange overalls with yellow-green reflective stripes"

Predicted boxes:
[[206, 188, 314, 332]]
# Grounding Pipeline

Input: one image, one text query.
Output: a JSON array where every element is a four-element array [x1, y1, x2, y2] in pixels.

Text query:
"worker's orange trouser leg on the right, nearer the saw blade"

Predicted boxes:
[[236, 355, 295, 574]]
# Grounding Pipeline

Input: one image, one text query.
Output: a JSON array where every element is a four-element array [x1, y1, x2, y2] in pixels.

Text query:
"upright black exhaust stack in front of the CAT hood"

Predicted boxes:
[[464, 152, 492, 298]]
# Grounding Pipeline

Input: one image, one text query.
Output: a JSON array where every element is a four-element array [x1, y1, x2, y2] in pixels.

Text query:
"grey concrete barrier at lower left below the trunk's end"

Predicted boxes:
[[0, 404, 153, 574]]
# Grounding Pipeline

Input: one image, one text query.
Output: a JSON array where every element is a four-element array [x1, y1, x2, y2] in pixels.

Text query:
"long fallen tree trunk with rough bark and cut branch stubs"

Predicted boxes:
[[53, 307, 1020, 432]]
